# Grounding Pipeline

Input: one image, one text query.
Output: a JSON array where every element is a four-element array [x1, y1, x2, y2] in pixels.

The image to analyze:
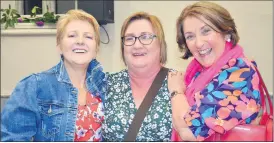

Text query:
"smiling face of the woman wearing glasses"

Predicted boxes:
[[123, 19, 160, 69]]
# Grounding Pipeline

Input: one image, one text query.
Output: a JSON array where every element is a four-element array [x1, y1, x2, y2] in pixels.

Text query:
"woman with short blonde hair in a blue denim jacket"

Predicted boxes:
[[1, 10, 105, 141]]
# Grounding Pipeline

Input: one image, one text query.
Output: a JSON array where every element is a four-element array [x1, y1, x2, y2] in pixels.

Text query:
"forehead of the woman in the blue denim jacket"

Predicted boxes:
[[65, 20, 94, 33]]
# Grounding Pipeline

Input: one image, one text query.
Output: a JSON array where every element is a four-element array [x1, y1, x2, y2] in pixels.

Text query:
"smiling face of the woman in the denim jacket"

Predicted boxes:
[[58, 20, 97, 66]]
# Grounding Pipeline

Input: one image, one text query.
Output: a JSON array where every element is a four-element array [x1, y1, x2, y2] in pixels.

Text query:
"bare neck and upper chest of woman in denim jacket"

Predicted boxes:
[[64, 61, 87, 89]]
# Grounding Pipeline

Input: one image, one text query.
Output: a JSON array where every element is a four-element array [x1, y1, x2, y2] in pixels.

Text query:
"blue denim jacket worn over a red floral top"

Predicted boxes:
[[1, 60, 106, 141]]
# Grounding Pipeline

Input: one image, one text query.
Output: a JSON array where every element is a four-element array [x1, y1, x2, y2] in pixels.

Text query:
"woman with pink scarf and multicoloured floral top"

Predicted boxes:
[[168, 2, 260, 141]]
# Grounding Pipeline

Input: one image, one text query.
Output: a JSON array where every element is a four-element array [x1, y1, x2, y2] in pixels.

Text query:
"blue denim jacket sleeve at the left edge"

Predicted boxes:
[[1, 75, 40, 141]]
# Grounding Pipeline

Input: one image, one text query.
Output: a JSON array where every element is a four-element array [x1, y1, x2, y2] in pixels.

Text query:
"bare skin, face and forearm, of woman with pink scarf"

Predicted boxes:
[[168, 17, 227, 141]]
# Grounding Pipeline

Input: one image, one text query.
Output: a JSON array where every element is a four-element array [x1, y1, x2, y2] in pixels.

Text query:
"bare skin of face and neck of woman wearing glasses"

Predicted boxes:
[[124, 19, 161, 108]]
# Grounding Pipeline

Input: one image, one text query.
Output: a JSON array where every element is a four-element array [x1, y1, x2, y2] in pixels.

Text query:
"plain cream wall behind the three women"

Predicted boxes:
[[1, 1, 273, 95]]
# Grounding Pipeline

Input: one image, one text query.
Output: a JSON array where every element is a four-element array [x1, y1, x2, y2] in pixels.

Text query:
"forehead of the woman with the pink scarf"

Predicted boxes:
[[183, 16, 217, 32]]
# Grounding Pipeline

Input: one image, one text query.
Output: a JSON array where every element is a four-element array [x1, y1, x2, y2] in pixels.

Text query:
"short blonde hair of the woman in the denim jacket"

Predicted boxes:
[[56, 9, 100, 49]]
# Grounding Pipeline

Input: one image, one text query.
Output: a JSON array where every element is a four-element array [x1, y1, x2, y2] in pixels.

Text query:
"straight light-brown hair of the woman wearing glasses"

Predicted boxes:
[[120, 12, 167, 65]]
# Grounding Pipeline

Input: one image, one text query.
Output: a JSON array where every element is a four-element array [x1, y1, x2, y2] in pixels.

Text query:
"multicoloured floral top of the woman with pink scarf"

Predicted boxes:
[[184, 60, 260, 140]]
